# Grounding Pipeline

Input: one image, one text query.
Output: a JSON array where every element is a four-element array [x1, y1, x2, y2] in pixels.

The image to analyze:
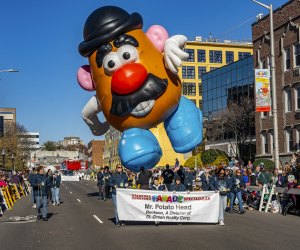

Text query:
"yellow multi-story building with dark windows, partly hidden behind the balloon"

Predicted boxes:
[[104, 37, 253, 169]]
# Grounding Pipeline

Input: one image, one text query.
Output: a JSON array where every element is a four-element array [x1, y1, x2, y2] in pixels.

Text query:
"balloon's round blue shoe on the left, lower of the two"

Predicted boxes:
[[118, 128, 162, 172]]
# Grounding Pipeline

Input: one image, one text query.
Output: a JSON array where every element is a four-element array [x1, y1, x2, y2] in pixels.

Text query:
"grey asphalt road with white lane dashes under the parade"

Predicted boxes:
[[0, 181, 300, 250]]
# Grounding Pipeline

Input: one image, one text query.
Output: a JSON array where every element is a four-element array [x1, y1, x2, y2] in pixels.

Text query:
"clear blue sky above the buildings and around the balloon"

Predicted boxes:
[[0, 0, 286, 143]]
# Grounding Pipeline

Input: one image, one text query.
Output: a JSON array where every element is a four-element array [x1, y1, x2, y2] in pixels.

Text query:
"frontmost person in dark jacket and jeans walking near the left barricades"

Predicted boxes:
[[31, 166, 51, 221]]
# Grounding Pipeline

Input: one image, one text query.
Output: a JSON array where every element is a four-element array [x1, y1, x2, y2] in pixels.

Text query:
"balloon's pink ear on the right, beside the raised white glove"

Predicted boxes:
[[146, 25, 169, 52]]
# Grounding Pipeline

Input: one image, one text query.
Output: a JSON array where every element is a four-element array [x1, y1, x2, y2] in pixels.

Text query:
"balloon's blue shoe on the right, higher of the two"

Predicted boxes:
[[164, 96, 203, 153]]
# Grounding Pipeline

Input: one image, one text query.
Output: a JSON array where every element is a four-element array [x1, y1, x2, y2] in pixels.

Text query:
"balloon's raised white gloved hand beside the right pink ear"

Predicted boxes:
[[164, 35, 189, 74]]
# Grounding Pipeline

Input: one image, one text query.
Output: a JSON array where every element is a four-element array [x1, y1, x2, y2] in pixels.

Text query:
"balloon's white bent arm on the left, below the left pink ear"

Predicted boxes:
[[81, 96, 109, 136]]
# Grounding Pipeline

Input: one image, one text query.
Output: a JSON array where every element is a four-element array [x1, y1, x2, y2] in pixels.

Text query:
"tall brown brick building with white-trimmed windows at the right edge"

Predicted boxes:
[[252, 0, 300, 162]]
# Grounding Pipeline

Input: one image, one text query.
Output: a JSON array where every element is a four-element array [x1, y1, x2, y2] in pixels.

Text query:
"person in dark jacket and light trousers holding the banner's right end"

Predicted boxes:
[[214, 168, 232, 226]]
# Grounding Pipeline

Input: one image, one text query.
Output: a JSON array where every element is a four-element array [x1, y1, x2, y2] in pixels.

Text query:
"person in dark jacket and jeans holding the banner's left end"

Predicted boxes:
[[109, 164, 128, 227]]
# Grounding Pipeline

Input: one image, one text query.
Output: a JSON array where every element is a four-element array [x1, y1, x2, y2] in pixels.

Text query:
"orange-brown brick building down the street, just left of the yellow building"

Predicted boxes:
[[88, 140, 105, 169]]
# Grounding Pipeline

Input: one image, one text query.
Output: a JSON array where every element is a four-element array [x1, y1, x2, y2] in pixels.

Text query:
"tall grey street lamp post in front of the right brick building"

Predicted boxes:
[[252, 0, 279, 169]]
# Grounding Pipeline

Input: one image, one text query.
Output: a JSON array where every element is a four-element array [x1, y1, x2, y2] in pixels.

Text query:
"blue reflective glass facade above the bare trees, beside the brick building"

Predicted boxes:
[[202, 56, 254, 117]]
